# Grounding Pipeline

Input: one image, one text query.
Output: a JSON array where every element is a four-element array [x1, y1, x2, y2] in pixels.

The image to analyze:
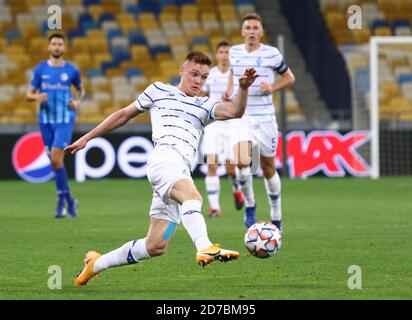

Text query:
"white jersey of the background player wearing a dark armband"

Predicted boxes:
[[229, 43, 288, 120]]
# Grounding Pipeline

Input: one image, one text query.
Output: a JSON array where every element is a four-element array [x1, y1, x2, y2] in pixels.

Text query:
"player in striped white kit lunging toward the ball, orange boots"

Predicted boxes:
[[65, 51, 256, 286]]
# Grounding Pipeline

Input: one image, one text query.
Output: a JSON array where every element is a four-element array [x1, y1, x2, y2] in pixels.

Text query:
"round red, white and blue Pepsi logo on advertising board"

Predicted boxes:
[[12, 132, 54, 183]]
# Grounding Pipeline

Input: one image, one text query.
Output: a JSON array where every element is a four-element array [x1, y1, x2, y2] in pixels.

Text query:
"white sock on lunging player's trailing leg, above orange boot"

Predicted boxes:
[[93, 238, 150, 272]]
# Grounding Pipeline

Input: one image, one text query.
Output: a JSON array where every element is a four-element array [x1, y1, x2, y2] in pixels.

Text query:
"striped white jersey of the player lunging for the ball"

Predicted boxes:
[[135, 82, 219, 167]]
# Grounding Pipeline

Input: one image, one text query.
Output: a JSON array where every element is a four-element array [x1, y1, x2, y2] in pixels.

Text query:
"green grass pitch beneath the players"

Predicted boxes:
[[0, 178, 412, 300]]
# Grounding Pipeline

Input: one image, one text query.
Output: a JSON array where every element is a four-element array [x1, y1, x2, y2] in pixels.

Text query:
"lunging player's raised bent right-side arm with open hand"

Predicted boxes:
[[214, 68, 258, 120]]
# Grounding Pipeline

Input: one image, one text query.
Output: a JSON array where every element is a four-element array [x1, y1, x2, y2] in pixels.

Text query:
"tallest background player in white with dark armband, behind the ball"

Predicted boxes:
[[223, 13, 295, 229]]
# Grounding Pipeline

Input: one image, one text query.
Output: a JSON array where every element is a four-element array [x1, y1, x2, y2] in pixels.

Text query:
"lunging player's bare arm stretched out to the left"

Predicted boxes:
[[64, 102, 142, 154]]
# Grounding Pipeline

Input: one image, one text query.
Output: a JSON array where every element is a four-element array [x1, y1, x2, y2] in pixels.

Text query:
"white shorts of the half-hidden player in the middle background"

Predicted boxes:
[[202, 119, 240, 163]]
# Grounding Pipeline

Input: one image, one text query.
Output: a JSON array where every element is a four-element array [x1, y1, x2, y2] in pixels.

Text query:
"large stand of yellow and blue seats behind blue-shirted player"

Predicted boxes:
[[0, 0, 302, 124]]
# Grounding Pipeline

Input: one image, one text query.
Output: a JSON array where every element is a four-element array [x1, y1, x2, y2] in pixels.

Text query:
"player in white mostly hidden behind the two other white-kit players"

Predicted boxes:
[[202, 41, 245, 217]]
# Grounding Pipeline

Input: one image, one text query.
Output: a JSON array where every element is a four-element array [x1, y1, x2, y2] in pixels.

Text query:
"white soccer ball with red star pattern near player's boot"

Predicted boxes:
[[245, 222, 282, 258]]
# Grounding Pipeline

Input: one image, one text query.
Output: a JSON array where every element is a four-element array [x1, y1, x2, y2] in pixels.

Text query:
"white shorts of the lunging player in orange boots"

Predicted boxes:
[[146, 146, 193, 223]]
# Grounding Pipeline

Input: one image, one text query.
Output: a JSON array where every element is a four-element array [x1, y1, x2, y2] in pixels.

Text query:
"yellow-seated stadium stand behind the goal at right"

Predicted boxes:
[[320, 0, 412, 121]]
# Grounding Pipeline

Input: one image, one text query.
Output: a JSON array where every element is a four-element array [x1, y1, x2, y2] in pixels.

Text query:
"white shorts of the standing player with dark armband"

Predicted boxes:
[[232, 116, 279, 157]]
